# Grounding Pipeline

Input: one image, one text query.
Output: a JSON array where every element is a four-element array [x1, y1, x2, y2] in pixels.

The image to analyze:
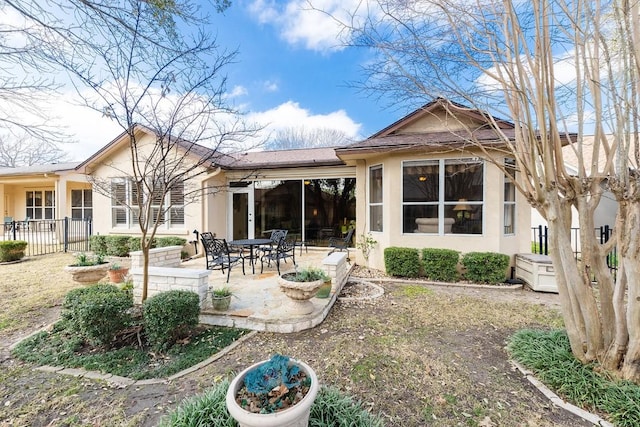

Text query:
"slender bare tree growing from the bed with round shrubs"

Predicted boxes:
[[47, 2, 253, 301]]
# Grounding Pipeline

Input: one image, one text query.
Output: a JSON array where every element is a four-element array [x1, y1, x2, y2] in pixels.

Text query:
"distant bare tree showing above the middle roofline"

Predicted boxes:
[[265, 126, 353, 150]]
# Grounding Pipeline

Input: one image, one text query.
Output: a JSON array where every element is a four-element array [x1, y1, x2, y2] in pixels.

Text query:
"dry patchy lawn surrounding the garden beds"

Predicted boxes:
[[0, 255, 589, 427]]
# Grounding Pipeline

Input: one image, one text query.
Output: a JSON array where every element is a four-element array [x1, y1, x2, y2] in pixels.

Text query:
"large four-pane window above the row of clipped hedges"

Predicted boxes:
[[402, 159, 484, 234]]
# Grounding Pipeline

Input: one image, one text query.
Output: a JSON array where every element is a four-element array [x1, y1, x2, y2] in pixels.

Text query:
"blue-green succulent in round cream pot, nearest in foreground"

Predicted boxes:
[[226, 354, 319, 427]]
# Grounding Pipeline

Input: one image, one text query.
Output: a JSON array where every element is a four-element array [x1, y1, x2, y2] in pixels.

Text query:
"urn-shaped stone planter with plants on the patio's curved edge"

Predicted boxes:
[[278, 267, 331, 315]]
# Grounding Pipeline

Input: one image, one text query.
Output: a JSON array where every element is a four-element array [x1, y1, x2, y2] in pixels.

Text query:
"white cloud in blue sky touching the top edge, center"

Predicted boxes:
[[249, 0, 366, 52]]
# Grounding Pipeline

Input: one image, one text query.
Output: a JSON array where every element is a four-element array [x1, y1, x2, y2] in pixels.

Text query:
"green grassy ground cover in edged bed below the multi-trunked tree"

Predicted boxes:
[[508, 330, 640, 427]]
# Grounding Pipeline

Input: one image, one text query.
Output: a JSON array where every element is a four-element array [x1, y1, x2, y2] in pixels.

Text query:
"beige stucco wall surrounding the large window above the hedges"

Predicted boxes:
[[356, 153, 530, 270]]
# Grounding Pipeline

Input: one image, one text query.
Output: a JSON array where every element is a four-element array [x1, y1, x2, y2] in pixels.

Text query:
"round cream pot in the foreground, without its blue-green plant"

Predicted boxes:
[[226, 359, 319, 427]]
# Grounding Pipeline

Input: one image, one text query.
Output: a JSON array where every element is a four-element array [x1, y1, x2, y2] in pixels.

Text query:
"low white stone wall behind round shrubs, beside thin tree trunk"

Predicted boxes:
[[129, 267, 211, 308]]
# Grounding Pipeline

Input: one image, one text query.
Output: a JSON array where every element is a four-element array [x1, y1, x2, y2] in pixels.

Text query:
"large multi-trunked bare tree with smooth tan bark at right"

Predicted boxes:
[[332, 0, 640, 382]]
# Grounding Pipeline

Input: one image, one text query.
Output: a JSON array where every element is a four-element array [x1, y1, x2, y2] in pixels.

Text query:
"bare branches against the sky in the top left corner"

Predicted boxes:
[[0, 0, 231, 159]]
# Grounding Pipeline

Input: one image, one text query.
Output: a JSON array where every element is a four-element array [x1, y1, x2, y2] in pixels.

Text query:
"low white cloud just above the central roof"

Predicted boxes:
[[248, 101, 362, 139]]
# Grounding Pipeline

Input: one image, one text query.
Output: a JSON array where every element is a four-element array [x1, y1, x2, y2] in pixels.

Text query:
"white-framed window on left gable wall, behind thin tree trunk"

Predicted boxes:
[[111, 178, 184, 227]]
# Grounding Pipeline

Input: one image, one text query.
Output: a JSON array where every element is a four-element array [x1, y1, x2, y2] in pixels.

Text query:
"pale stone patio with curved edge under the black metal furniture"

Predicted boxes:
[[181, 248, 353, 333]]
